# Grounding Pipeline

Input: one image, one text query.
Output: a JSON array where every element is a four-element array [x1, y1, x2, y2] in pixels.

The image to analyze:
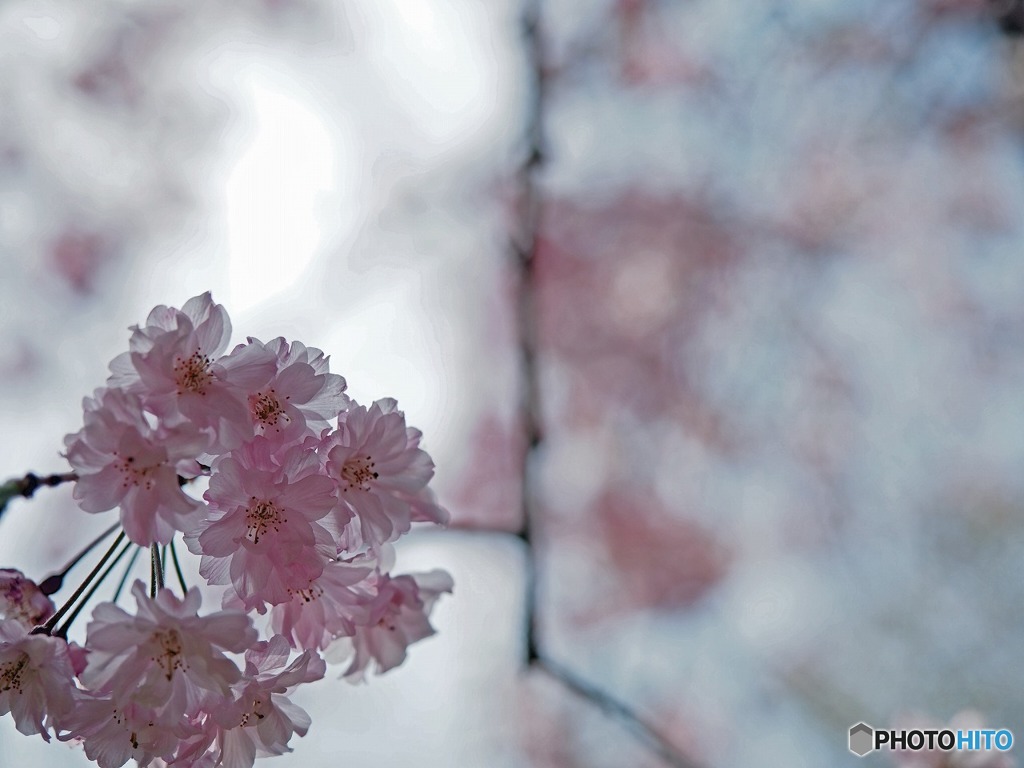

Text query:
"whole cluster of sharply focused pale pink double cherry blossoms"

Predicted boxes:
[[0, 293, 452, 768]]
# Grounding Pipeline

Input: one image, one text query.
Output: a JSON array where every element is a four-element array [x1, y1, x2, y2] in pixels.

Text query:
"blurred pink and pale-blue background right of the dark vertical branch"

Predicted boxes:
[[460, 0, 1024, 766]]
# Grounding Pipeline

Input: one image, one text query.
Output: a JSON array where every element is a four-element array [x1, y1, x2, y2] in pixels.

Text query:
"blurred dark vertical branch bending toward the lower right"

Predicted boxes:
[[509, 6, 697, 768]]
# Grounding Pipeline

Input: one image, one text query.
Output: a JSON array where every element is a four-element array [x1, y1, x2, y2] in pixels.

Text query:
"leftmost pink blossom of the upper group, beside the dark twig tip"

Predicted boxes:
[[65, 389, 210, 546]]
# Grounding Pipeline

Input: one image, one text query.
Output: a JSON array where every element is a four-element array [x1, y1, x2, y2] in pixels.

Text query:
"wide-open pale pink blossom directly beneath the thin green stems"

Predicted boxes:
[[80, 582, 257, 724]]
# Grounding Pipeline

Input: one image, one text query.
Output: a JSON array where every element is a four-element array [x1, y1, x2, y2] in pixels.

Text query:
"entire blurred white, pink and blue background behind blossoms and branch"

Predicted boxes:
[[0, 0, 1024, 768]]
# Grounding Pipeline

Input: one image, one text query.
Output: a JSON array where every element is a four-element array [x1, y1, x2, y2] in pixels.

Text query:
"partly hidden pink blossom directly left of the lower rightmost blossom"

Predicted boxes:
[[270, 561, 376, 650]]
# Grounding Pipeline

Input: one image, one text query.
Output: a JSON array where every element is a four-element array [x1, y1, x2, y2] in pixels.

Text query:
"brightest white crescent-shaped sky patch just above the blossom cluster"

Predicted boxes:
[[225, 67, 350, 313]]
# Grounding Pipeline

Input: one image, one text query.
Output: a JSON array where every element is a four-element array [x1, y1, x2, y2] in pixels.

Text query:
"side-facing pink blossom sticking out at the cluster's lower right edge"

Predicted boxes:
[[325, 570, 454, 682]]
